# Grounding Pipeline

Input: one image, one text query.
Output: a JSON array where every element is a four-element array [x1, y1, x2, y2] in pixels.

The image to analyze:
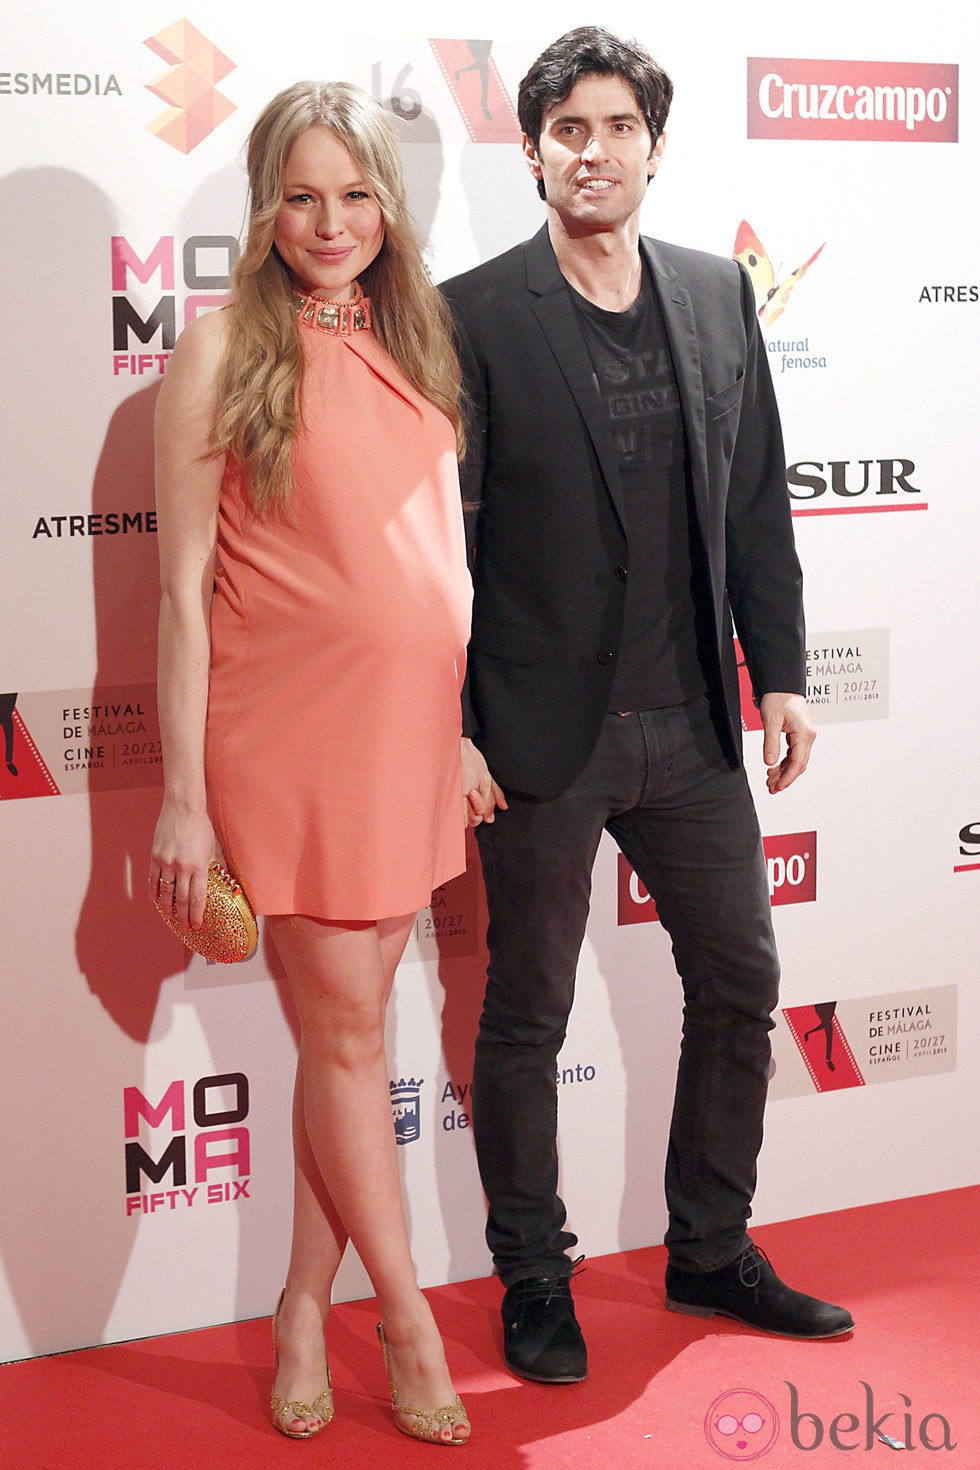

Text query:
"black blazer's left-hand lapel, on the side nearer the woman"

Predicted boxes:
[[527, 225, 626, 529]]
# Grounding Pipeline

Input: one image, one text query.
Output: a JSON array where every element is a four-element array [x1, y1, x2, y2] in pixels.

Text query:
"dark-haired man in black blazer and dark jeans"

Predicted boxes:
[[444, 26, 854, 1383]]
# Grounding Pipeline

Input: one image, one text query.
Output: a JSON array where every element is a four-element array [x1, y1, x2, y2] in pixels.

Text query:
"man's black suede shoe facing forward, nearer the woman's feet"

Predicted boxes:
[[501, 1276, 589, 1383]]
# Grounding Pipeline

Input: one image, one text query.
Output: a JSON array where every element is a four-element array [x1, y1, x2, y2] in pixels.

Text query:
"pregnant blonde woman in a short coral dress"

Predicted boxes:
[[150, 82, 494, 1445]]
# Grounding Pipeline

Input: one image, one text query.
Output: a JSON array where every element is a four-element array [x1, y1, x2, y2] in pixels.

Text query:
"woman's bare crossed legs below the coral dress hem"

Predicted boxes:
[[269, 916, 469, 1438]]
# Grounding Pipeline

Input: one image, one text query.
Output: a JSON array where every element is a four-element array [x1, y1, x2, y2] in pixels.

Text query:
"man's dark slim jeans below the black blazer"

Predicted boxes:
[[473, 697, 779, 1285]]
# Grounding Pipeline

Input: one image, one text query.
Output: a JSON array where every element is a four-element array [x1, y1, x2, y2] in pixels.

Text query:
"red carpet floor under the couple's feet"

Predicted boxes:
[[0, 1189, 980, 1470]]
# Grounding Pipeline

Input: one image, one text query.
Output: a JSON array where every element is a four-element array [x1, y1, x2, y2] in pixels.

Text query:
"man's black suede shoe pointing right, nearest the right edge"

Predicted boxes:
[[666, 1241, 854, 1338]]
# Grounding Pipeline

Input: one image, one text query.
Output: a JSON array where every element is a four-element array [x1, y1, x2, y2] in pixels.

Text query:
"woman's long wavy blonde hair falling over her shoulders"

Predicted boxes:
[[212, 82, 463, 515]]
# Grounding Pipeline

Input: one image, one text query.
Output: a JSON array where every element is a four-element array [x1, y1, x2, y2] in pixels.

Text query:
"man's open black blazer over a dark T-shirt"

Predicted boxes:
[[442, 226, 805, 798]]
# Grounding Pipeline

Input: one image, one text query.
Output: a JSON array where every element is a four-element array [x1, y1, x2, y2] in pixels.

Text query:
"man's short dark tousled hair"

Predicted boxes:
[[517, 25, 674, 198]]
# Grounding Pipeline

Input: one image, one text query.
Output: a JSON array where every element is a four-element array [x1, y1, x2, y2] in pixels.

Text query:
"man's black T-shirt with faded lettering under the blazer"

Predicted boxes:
[[569, 272, 705, 710]]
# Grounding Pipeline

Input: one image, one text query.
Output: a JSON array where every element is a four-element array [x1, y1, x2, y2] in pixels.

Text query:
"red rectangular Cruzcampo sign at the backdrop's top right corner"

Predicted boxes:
[[748, 56, 959, 143]]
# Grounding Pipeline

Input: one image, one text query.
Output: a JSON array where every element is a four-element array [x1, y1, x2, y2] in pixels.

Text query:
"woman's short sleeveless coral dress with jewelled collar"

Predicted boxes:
[[206, 292, 472, 922]]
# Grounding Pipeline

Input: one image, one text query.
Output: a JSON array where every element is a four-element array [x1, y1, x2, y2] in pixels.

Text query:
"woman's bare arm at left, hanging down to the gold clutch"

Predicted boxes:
[[150, 312, 228, 929]]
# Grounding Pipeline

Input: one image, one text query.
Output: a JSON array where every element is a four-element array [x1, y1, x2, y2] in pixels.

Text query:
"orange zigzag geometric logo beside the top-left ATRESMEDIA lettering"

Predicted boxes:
[[143, 21, 235, 153]]
